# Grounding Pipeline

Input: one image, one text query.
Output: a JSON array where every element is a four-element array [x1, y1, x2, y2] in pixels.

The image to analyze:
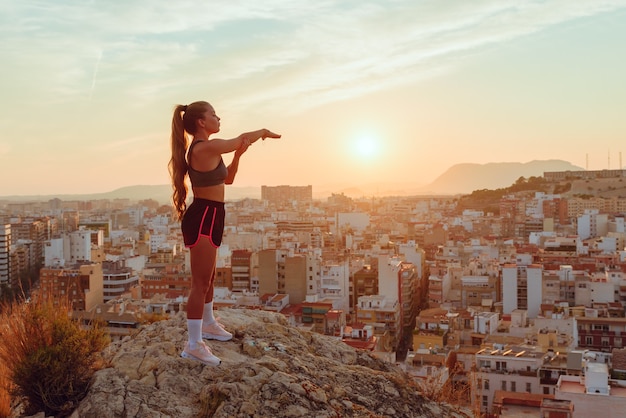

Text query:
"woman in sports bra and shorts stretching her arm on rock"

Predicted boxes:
[[169, 102, 280, 365]]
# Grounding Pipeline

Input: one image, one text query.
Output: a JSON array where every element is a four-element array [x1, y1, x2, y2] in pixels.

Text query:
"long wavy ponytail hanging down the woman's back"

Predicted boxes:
[[168, 105, 187, 220]]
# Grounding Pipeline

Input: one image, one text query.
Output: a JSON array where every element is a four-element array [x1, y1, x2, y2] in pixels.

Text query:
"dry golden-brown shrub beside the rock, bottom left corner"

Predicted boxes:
[[0, 300, 109, 417]]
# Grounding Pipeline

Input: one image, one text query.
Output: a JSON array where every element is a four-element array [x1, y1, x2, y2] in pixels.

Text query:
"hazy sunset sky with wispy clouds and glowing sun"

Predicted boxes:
[[0, 0, 626, 196]]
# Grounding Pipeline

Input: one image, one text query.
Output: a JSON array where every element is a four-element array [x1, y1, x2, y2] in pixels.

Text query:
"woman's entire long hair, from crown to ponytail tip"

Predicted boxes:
[[168, 102, 211, 219]]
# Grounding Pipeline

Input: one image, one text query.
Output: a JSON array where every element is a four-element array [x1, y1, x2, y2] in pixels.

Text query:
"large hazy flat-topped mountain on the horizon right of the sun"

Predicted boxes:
[[420, 160, 584, 194]]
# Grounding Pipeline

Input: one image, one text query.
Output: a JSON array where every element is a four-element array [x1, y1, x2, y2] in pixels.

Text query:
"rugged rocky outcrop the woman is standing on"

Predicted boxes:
[[67, 309, 471, 418]]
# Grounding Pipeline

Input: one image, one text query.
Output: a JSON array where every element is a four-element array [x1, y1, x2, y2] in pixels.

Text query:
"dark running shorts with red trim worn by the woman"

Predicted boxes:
[[181, 198, 226, 248]]
